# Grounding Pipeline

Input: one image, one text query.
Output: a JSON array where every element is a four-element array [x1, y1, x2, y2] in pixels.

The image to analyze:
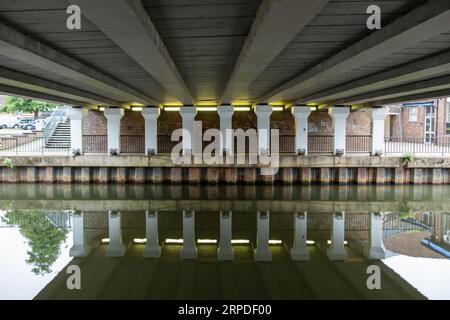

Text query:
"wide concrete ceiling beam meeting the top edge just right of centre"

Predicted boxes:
[[222, 0, 329, 103]]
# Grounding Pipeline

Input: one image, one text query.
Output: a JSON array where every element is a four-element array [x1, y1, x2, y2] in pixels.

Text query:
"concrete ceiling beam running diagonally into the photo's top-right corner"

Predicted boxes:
[[259, 0, 450, 102]]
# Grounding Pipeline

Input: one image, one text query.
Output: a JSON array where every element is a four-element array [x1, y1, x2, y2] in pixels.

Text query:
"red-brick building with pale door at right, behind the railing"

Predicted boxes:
[[387, 98, 450, 141]]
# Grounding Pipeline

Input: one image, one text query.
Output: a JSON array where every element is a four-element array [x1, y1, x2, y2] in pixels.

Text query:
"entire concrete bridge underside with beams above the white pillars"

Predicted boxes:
[[0, 0, 450, 107]]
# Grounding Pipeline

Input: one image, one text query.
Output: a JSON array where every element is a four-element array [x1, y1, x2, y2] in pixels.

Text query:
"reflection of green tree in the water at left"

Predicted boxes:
[[2, 210, 68, 275]]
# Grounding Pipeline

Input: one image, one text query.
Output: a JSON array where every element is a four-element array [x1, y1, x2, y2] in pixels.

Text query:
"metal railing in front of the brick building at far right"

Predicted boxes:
[[385, 137, 450, 155]]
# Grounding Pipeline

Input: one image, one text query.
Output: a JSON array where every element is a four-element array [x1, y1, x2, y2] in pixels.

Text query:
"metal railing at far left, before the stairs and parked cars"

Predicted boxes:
[[0, 137, 70, 156]]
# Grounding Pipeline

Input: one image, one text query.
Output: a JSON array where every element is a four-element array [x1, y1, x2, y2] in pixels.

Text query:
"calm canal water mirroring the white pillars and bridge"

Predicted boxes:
[[0, 184, 450, 299]]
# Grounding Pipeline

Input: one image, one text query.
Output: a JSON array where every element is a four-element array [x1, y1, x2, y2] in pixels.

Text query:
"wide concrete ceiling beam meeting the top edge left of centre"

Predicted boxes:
[[69, 0, 194, 104]]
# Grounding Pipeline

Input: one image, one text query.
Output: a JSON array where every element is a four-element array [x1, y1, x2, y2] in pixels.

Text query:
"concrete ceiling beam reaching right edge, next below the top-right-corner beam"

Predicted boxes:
[[297, 51, 450, 103]]
